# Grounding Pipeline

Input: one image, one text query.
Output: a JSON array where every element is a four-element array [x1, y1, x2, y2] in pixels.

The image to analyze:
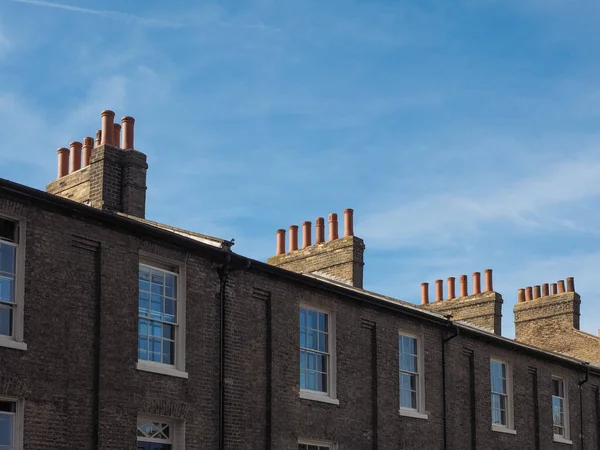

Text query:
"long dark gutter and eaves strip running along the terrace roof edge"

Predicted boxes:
[[0, 178, 600, 375]]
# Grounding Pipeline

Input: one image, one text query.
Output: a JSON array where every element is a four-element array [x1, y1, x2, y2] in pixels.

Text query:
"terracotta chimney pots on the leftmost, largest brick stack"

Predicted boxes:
[[58, 110, 135, 179]]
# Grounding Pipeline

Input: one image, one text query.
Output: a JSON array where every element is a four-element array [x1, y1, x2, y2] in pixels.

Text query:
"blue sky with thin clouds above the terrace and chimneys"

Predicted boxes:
[[0, 0, 600, 336]]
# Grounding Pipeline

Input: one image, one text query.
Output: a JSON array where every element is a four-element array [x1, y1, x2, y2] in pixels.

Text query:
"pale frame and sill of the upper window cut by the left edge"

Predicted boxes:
[[0, 212, 27, 350]]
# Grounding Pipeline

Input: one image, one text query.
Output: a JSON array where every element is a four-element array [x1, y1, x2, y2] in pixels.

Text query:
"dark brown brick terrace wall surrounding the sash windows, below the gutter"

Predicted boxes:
[[0, 180, 600, 450]]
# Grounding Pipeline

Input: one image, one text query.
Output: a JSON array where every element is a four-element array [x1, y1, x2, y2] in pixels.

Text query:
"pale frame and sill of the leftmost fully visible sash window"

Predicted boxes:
[[136, 252, 188, 378]]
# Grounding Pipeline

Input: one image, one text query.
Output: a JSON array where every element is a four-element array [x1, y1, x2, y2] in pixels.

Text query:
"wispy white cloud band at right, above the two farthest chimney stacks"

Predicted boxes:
[[359, 154, 600, 248]]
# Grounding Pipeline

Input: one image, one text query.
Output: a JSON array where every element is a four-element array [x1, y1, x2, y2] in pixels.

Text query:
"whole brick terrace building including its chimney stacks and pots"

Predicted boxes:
[[0, 111, 600, 450]]
